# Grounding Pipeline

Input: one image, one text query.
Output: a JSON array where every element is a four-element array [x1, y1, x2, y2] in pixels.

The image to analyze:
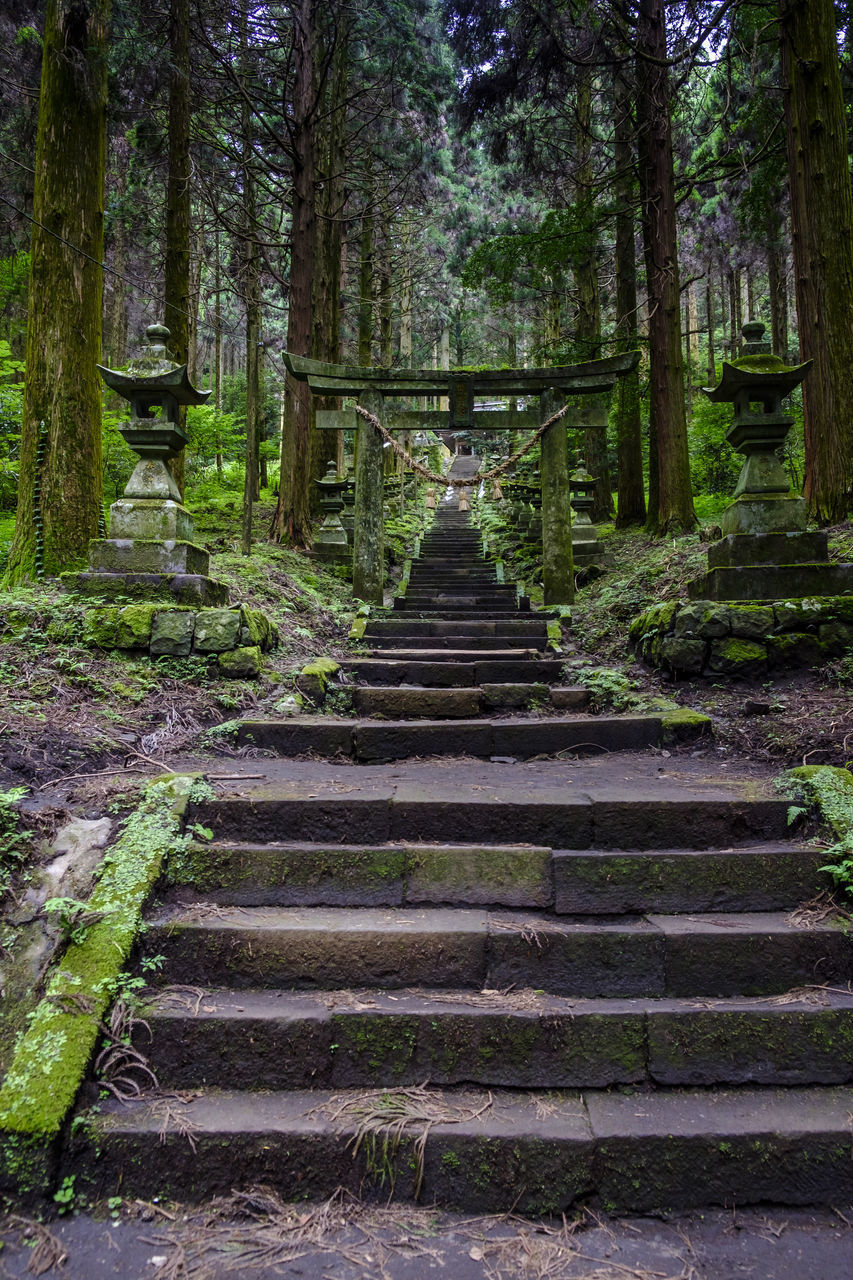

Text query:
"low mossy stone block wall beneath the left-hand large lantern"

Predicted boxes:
[[83, 602, 279, 680]]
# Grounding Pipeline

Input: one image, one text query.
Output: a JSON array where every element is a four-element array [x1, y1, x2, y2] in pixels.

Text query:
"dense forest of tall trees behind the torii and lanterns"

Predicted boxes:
[[0, 0, 853, 582]]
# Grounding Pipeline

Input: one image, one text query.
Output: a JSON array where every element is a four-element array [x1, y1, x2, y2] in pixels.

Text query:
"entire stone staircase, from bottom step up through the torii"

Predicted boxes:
[[68, 504, 853, 1213]]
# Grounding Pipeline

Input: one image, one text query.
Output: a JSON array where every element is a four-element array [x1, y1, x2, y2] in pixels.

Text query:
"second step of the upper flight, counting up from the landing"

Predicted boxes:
[[341, 681, 588, 719]]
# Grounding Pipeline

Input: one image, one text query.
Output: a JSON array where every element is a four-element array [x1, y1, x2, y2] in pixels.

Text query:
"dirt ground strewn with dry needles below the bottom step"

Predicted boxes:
[[0, 1190, 853, 1280]]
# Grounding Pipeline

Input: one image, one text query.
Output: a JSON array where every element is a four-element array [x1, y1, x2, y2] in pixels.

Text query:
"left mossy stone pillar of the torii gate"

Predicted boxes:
[[352, 390, 386, 604]]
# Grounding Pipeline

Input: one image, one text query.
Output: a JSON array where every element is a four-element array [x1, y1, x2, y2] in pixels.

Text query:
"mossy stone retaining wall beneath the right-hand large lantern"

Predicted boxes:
[[629, 595, 853, 677]]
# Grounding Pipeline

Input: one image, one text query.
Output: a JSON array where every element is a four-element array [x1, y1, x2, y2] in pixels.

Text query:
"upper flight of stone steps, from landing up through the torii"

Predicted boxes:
[[238, 506, 686, 762]]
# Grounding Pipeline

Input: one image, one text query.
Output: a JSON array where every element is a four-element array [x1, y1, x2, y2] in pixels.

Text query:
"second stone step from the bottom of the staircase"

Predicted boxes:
[[137, 987, 853, 1091]]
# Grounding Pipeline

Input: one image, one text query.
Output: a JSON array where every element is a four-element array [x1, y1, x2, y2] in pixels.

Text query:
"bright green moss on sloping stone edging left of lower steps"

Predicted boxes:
[[0, 777, 193, 1192]]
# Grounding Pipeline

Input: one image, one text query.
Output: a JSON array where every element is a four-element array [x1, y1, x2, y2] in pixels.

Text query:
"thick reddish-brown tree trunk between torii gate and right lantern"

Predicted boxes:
[[637, 0, 697, 534]]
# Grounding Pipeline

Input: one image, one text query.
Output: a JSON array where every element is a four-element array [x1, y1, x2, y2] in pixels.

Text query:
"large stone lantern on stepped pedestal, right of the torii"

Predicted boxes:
[[688, 320, 853, 600]]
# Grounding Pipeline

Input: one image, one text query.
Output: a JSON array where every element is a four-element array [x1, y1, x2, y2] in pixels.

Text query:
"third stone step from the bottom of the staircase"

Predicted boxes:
[[146, 902, 853, 998]]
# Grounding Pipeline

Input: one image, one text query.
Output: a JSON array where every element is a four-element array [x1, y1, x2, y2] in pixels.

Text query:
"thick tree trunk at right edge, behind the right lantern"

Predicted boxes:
[[779, 0, 853, 525]]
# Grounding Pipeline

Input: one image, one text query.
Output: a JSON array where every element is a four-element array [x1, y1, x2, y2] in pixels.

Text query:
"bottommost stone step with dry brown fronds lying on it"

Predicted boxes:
[[69, 1085, 853, 1213]]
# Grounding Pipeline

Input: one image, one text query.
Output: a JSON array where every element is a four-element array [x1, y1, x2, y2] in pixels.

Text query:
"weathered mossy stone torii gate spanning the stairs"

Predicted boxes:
[[283, 351, 639, 604]]
